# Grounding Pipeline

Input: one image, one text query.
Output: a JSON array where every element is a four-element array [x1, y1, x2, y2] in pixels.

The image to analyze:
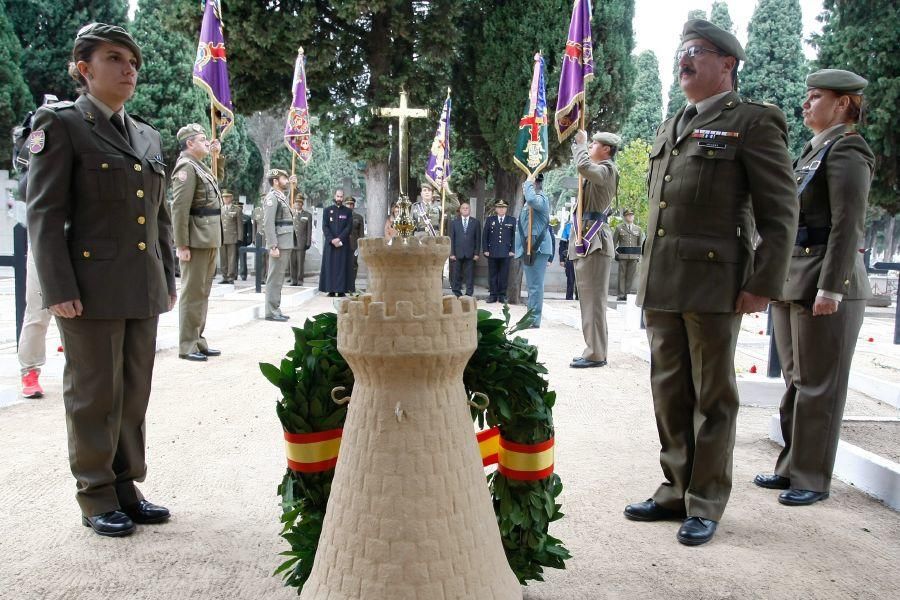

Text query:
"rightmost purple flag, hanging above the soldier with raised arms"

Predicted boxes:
[[554, 0, 594, 142]]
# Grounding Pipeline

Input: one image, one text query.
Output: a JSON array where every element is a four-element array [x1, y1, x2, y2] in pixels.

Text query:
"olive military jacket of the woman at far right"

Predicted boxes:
[[781, 126, 875, 302]]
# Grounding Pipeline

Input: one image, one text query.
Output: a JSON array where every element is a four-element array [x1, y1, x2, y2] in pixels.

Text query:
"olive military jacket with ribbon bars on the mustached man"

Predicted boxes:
[[637, 92, 798, 313]]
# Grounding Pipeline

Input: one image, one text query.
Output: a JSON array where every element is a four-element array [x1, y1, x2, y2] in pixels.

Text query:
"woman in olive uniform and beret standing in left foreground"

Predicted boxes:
[[27, 23, 175, 537]]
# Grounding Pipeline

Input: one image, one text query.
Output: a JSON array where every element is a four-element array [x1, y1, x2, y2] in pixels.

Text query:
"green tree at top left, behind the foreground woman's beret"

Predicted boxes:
[[10, 0, 128, 104]]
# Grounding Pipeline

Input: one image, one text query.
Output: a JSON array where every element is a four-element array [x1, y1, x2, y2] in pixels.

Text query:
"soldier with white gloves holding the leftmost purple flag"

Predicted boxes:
[[172, 123, 224, 361]]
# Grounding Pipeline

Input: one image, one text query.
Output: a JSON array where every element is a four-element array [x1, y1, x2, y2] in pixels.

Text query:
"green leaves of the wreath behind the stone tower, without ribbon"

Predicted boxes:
[[260, 306, 571, 594]]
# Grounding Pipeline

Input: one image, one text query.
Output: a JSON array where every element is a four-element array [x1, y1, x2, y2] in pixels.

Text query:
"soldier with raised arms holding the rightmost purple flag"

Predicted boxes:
[[569, 131, 622, 369]]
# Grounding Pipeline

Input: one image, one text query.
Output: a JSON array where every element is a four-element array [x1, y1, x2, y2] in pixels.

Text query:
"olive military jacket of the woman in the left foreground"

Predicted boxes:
[[27, 96, 175, 319]]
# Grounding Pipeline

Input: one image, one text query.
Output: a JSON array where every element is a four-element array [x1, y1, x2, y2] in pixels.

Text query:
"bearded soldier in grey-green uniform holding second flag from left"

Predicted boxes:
[[263, 169, 296, 321]]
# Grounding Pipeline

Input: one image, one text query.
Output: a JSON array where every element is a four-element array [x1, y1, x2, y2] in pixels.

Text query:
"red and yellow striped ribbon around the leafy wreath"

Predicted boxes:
[[284, 427, 555, 481]]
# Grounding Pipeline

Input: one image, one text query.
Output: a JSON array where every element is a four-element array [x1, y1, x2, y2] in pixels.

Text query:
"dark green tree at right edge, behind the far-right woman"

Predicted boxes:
[[813, 0, 900, 214]]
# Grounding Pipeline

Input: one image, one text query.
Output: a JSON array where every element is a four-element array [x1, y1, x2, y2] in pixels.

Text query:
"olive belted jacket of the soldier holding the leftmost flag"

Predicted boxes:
[[172, 152, 225, 248]]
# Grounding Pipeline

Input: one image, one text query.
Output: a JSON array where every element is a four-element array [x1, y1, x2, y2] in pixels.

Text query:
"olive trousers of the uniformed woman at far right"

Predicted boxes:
[[772, 300, 866, 492]]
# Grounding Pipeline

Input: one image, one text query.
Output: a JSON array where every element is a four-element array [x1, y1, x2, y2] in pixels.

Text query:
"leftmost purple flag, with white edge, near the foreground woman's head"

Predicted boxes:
[[194, 0, 234, 137]]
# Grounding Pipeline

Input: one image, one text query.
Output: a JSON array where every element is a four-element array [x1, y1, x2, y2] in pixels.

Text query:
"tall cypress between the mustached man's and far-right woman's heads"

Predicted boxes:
[[740, 0, 808, 156]]
